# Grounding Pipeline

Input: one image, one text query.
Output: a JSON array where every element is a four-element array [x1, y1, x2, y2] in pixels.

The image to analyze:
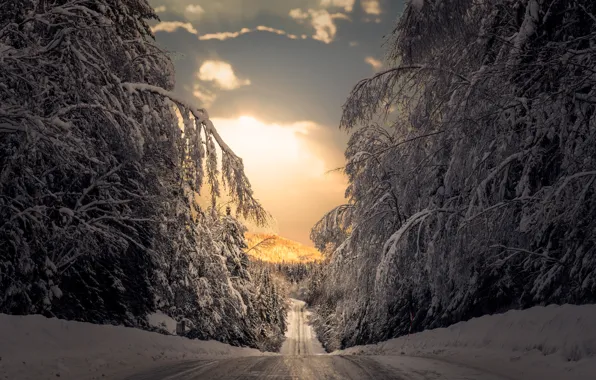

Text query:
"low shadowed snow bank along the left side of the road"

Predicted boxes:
[[0, 314, 262, 380]]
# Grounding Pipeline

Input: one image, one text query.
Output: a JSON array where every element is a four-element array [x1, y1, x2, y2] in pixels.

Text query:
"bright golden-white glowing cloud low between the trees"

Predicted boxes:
[[212, 114, 346, 244]]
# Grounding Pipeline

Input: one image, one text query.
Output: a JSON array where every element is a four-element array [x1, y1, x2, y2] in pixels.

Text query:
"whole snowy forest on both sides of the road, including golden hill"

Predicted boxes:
[[0, 0, 596, 351]]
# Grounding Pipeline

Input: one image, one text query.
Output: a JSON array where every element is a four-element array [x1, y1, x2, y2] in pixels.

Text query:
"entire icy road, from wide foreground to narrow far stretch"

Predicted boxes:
[[126, 300, 510, 380]]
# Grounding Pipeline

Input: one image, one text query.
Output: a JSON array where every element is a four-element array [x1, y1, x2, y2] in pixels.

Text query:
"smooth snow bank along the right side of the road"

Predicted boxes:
[[334, 305, 596, 380]]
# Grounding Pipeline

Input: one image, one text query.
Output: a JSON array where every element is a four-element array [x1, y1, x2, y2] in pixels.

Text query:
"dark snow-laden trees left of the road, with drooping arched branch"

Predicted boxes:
[[0, 0, 285, 348]]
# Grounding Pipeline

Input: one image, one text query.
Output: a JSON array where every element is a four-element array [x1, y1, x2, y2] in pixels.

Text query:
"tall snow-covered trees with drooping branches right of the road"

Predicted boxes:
[[310, 0, 596, 349]]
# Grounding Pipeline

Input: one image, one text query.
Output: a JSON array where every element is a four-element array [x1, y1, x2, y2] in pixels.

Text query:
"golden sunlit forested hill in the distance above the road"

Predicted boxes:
[[245, 232, 323, 263]]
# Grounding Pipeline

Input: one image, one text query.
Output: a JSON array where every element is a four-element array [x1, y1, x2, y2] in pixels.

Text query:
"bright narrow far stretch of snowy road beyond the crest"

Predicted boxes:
[[279, 299, 325, 355]]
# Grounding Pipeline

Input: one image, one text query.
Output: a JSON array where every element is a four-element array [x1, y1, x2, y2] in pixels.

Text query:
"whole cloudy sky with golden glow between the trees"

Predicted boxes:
[[149, 0, 404, 245]]
